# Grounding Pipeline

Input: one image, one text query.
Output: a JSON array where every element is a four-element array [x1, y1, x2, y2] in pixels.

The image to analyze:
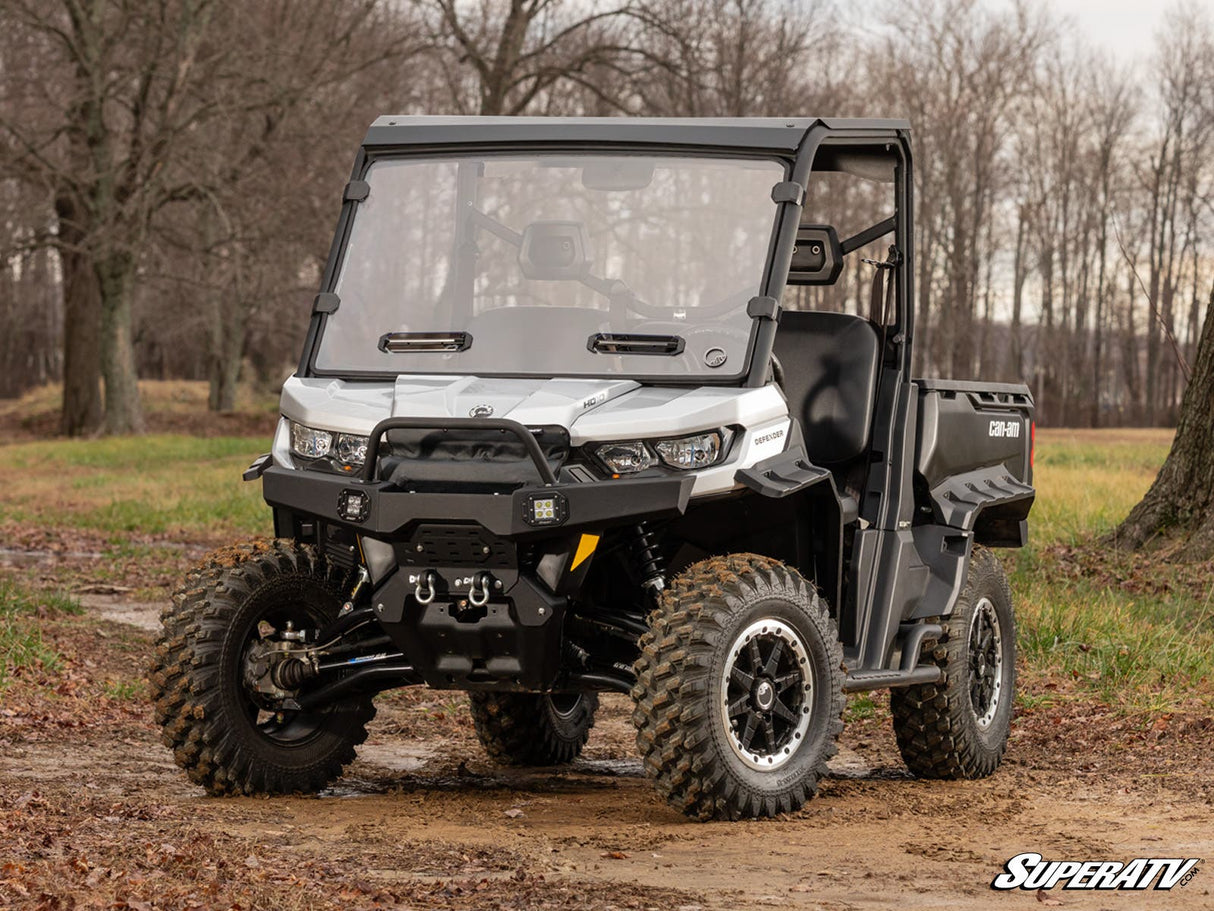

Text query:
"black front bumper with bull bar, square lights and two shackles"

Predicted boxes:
[[256, 419, 696, 692]]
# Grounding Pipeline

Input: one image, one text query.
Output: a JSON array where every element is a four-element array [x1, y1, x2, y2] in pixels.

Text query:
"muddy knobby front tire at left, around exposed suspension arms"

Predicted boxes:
[[149, 541, 375, 796]]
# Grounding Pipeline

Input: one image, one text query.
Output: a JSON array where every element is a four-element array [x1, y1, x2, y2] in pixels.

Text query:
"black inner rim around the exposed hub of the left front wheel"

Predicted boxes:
[[239, 599, 327, 747]]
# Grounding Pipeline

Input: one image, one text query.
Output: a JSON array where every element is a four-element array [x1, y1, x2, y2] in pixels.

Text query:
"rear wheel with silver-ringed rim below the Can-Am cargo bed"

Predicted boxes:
[[890, 548, 1016, 779]]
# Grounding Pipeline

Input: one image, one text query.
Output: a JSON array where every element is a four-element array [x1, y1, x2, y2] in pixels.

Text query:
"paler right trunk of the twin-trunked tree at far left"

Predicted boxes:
[[96, 253, 144, 434]]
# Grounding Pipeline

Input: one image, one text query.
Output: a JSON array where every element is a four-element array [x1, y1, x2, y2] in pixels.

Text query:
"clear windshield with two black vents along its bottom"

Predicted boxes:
[[314, 154, 784, 377]]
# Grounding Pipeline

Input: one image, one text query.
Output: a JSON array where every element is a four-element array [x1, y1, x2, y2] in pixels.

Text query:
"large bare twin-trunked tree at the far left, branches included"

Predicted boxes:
[[0, 0, 253, 434]]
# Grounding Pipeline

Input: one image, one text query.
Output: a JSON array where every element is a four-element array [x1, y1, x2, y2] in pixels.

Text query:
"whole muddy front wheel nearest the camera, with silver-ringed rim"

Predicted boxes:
[[632, 554, 844, 819]]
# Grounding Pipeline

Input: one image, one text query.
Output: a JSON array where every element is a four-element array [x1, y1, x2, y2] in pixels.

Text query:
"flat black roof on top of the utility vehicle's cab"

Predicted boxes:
[[363, 114, 911, 153]]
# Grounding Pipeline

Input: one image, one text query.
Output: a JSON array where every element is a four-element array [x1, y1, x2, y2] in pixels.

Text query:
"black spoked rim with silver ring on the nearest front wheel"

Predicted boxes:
[[721, 619, 813, 771]]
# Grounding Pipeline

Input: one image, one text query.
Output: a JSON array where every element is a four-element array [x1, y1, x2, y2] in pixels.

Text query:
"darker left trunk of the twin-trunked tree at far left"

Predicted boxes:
[[55, 197, 102, 436]]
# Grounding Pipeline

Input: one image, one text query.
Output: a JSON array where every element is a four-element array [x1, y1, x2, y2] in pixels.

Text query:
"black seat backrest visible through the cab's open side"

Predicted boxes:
[[775, 311, 881, 465]]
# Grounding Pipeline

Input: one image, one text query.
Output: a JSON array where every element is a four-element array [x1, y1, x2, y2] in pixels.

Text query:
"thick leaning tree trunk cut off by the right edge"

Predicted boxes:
[[1112, 281, 1214, 560]]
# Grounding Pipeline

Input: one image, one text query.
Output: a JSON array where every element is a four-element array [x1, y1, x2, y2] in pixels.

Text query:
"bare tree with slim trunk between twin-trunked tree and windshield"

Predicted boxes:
[[176, 0, 422, 411]]
